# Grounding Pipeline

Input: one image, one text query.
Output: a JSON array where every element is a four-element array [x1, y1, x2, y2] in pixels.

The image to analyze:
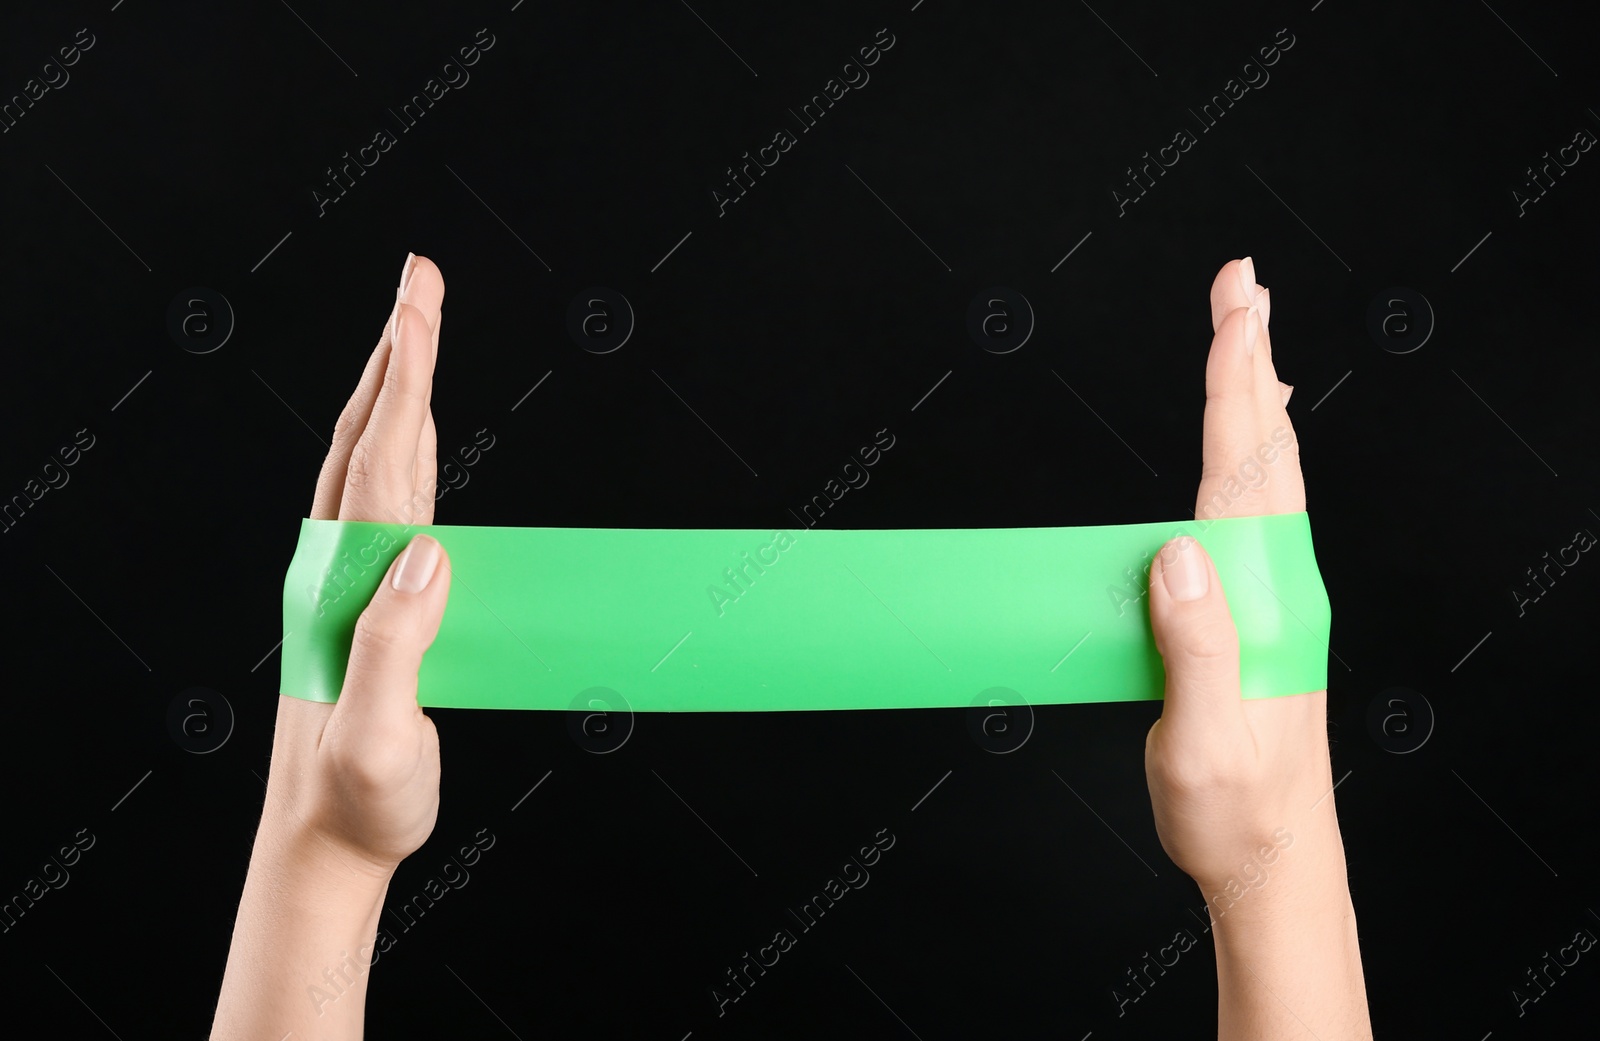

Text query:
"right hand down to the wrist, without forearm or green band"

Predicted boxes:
[[1146, 261, 1339, 915]]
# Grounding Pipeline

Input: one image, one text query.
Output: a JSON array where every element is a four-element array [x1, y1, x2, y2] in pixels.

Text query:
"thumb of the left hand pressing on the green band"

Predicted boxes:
[[334, 534, 450, 723]]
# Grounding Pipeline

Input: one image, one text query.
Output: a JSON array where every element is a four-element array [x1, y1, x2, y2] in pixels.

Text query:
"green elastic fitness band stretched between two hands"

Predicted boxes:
[[280, 512, 1331, 712]]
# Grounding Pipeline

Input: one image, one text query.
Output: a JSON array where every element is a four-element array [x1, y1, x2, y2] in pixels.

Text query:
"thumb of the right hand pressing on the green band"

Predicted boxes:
[[1150, 536, 1245, 748]]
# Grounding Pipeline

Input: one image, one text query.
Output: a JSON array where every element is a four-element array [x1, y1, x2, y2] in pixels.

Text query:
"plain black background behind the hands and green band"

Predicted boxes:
[[0, 0, 1600, 1041]]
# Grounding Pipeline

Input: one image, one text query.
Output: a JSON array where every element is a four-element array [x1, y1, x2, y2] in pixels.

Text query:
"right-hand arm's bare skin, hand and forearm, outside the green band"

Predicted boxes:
[[1144, 257, 1371, 1039]]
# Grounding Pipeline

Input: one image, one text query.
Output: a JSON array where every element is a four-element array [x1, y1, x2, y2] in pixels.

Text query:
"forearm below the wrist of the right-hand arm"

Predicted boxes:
[[1208, 827, 1373, 1041]]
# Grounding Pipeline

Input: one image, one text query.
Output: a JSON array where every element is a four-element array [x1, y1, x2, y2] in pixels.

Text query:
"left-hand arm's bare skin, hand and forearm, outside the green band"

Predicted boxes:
[[211, 257, 450, 1041]]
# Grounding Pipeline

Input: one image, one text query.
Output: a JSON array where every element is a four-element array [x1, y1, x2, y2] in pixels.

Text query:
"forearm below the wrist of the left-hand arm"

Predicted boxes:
[[211, 816, 389, 1041]]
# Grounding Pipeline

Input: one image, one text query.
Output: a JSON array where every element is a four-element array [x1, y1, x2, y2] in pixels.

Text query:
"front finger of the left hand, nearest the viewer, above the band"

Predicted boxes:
[[339, 304, 434, 523]]
